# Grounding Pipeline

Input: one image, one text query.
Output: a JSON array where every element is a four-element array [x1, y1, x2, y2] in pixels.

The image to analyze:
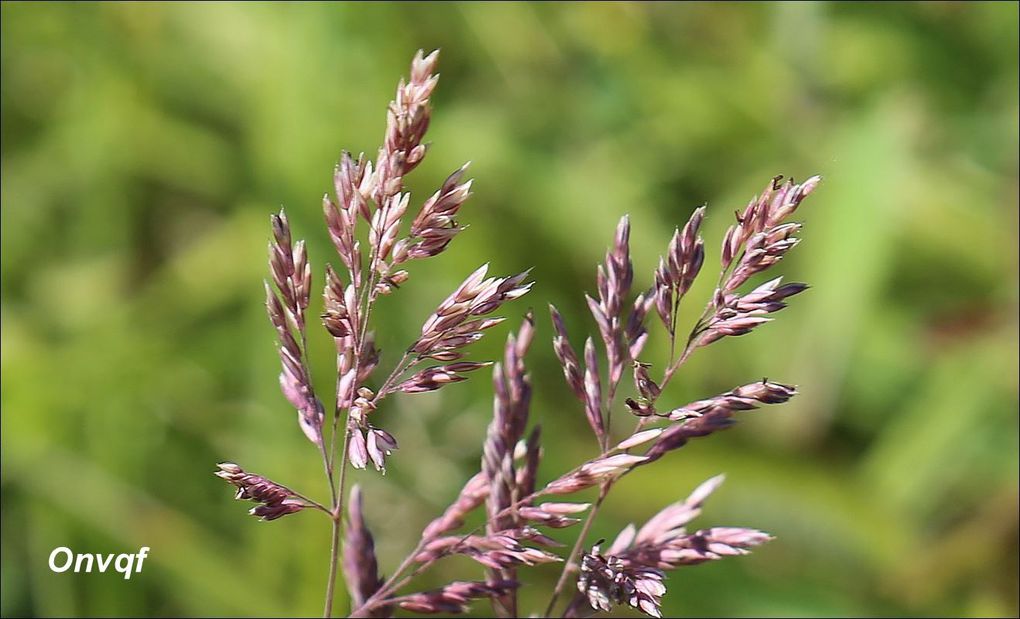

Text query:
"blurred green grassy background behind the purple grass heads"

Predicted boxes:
[[0, 2, 1018, 616]]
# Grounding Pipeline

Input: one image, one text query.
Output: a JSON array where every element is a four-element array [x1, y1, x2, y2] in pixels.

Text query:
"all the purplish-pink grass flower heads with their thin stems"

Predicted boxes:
[[217, 52, 818, 617]]
